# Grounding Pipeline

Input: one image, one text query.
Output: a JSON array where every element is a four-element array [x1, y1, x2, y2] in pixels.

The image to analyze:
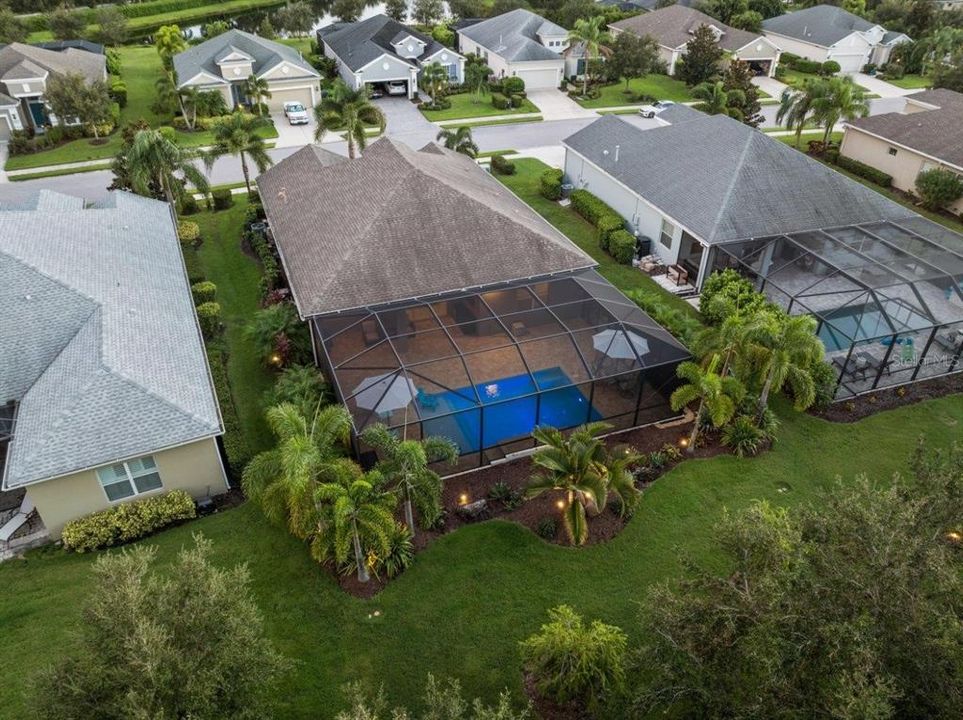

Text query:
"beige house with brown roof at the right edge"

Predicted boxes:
[[839, 89, 963, 213]]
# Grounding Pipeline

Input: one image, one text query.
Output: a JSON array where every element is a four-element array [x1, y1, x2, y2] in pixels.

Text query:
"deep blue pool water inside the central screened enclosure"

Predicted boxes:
[[424, 367, 602, 454]]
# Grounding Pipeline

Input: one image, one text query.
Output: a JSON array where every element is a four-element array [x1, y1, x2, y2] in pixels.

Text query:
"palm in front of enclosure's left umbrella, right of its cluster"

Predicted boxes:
[[361, 424, 458, 537]]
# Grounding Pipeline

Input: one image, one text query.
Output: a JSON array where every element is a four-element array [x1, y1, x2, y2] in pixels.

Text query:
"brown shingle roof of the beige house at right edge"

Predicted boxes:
[[848, 90, 963, 167]]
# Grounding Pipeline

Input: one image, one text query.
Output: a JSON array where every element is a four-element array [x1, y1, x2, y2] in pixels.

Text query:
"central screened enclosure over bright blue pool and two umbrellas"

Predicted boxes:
[[312, 271, 689, 472]]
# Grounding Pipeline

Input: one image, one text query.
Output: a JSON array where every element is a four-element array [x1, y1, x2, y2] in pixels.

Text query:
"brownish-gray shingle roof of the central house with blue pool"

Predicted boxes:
[[258, 138, 595, 317]]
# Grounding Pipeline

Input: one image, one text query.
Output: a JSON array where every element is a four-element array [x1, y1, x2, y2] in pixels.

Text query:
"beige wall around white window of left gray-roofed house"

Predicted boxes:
[[27, 438, 228, 539]]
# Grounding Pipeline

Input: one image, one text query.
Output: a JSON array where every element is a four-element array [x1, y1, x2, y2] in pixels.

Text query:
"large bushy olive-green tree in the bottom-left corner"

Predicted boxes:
[[28, 534, 291, 720]]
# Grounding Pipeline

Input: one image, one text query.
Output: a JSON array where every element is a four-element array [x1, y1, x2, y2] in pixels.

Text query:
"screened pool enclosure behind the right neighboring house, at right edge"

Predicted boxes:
[[710, 216, 963, 399]]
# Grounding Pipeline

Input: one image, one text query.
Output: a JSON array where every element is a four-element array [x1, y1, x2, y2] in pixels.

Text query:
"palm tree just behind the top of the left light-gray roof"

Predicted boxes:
[[127, 130, 210, 213]]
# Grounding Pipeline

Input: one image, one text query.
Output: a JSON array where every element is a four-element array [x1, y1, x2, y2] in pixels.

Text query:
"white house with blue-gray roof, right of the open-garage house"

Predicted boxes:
[[457, 9, 577, 90]]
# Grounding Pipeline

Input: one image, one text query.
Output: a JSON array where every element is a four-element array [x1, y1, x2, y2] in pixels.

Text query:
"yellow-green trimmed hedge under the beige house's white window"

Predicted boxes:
[[61, 490, 197, 552]]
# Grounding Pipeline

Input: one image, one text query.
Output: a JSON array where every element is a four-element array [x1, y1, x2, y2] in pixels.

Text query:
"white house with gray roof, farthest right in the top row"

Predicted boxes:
[[762, 5, 910, 74]]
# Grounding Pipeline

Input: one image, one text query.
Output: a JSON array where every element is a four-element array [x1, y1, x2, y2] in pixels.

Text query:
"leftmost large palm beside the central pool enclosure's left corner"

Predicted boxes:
[[241, 403, 351, 539]]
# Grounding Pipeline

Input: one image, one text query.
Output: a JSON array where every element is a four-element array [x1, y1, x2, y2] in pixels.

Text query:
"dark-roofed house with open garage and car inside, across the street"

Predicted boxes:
[[317, 15, 465, 98]]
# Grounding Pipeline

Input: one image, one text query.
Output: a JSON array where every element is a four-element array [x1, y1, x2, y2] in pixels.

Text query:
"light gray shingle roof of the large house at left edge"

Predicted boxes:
[[0, 191, 221, 489]]
